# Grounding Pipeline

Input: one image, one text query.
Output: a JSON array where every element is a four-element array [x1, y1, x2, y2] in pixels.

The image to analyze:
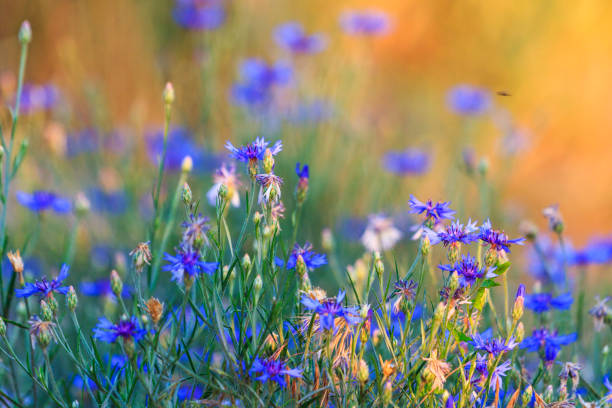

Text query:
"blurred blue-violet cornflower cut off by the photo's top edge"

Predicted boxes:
[[172, 0, 225, 30]]
